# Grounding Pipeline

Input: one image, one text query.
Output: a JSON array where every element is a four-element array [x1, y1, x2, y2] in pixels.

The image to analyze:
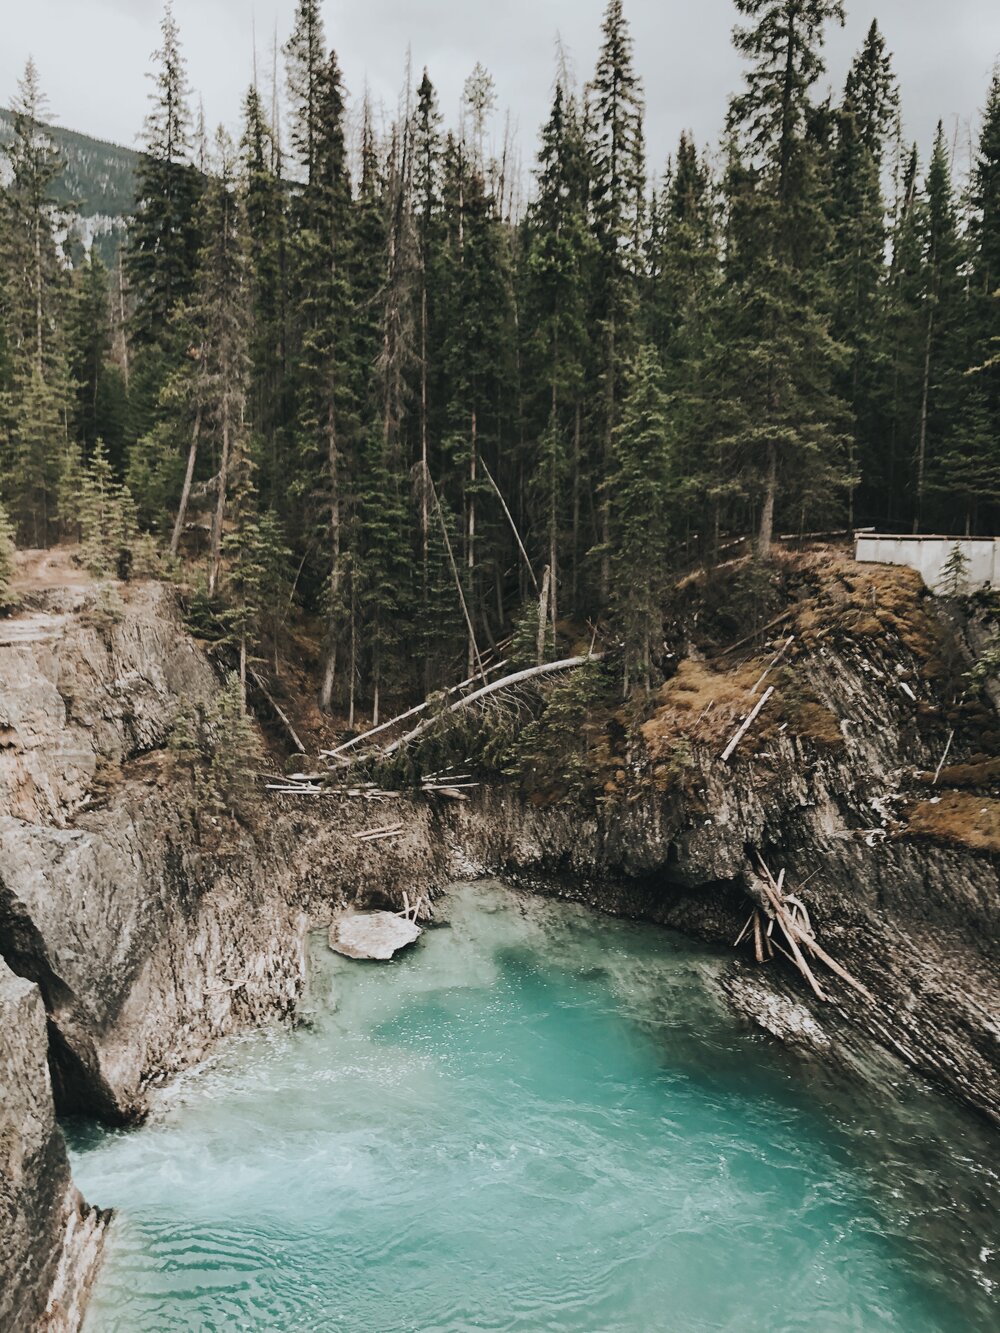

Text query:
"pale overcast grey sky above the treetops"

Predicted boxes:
[[0, 0, 1000, 177]]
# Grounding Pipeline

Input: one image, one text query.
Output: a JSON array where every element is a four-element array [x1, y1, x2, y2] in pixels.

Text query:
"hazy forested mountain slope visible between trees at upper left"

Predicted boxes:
[[0, 107, 140, 264]]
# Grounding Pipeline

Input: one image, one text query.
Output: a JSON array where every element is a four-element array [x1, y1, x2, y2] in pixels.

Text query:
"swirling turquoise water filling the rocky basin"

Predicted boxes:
[[71, 886, 1000, 1333]]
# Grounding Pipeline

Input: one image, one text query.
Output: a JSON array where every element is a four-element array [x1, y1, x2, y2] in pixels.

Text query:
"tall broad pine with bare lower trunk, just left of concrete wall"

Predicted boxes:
[[717, 0, 849, 556]]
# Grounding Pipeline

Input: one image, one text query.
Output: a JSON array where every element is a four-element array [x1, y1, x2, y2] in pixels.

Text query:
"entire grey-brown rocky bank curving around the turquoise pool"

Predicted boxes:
[[0, 551, 1000, 1329]]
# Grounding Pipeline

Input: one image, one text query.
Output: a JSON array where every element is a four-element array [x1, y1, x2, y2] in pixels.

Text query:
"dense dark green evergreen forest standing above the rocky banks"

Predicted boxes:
[[0, 0, 1000, 725]]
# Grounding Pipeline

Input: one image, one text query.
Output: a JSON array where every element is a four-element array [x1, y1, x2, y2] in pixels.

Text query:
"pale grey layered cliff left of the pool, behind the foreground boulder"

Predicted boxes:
[[0, 584, 303, 1120]]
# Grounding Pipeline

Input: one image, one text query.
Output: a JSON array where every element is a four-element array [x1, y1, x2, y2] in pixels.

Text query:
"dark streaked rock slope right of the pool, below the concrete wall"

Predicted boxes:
[[437, 587, 1000, 1122]]
